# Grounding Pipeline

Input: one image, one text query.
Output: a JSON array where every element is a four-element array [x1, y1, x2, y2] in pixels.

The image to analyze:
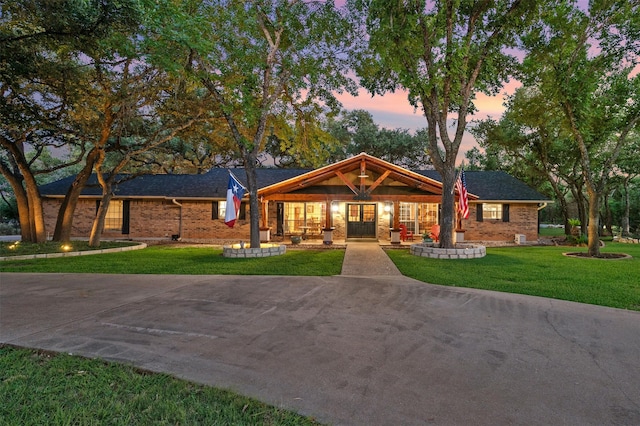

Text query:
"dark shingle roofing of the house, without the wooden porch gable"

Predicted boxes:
[[40, 168, 548, 201]]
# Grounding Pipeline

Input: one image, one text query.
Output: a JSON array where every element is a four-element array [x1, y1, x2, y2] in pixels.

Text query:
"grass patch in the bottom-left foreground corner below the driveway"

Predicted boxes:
[[0, 345, 319, 426]]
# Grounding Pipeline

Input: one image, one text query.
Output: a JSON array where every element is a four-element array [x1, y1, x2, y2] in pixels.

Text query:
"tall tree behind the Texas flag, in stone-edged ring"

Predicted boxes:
[[156, 0, 356, 246]]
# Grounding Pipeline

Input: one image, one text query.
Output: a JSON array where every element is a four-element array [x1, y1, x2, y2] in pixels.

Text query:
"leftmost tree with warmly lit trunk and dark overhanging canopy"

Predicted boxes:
[[0, 0, 144, 242]]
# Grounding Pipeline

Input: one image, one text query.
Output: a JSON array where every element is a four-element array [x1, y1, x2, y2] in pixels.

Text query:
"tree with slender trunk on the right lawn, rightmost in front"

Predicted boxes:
[[523, 0, 640, 256]]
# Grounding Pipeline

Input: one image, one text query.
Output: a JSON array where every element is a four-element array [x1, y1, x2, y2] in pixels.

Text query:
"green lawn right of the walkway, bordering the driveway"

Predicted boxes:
[[387, 243, 640, 310]]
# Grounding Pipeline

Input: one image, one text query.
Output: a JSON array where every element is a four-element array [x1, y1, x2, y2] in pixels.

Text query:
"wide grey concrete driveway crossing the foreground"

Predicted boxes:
[[0, 273, 640, 425]]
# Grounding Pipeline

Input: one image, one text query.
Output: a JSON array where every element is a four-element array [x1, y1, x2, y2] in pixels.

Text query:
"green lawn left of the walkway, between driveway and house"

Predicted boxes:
[[0, 246, 344, 276]]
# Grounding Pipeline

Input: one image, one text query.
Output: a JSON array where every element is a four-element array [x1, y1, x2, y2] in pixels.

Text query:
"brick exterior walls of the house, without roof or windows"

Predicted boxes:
[[43, 198, 538, 242]]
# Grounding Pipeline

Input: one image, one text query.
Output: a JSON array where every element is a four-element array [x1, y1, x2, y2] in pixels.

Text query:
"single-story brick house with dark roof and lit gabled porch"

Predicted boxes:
[[41, 153, 550, 242]]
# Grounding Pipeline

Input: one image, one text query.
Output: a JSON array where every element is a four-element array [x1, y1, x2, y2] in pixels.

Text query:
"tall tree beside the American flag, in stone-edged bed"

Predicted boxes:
[[350, 0, 540, 247]]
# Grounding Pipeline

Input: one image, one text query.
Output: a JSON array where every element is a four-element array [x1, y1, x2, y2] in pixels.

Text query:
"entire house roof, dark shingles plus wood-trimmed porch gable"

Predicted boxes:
[[40, 153, 550, 202]]
